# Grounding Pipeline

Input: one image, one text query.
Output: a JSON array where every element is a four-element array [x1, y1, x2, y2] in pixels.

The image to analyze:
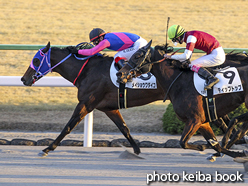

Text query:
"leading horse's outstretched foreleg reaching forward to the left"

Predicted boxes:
[[39, 102, 91, 156]]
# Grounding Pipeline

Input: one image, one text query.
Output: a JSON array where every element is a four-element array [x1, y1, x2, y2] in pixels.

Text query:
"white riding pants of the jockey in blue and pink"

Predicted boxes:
[[114, 37, 147, 60]]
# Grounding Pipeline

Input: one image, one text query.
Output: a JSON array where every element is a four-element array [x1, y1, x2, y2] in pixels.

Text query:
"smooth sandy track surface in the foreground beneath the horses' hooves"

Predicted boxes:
[[0, 146, 248, 186]]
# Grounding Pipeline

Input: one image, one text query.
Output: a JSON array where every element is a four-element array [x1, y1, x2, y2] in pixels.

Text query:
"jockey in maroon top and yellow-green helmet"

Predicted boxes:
[[164, 25, 226, 89]]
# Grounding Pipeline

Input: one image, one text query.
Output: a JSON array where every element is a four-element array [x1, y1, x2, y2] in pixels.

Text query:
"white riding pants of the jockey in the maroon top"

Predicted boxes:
[[189, 47, 226, 67]]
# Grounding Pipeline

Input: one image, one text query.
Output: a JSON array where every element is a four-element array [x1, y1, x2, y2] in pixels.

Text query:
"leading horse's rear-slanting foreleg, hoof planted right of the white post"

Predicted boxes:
[[105, 110, 140, 154]]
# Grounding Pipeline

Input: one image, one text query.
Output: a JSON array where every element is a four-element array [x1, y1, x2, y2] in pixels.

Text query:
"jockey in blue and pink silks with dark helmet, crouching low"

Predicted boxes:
[[72, 28, 147, 67]]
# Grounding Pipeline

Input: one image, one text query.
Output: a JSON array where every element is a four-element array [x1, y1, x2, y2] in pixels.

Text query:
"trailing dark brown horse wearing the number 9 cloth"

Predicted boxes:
[[117, 41, 248, 157]]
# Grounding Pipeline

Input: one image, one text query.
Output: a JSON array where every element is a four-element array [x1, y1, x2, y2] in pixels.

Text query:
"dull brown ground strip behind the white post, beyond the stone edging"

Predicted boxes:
[[0, 101, 170, 133]]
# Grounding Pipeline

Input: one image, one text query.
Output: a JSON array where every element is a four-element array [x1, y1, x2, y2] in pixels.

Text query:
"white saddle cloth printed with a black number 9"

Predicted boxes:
[[194, 67, 243, 96]]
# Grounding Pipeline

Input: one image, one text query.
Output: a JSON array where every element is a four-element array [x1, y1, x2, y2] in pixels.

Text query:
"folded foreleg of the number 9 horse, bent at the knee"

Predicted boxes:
[[180, 123, 208, 151]]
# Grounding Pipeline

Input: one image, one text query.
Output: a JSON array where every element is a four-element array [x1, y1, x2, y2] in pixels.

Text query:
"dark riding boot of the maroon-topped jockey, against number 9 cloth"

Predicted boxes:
[[198, 67, 220, 90]]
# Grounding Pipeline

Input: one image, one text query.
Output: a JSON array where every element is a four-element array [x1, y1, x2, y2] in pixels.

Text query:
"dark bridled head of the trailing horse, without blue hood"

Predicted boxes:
[[116, 40, 152, 83]]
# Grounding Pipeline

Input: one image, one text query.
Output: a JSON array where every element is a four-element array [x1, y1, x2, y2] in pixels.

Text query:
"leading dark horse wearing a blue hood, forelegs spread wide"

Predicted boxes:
[[21, 42, 167, 156]]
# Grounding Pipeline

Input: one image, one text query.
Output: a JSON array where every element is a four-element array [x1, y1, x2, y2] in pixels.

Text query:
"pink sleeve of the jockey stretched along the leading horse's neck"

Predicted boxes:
[[78, 39, 110, 56]]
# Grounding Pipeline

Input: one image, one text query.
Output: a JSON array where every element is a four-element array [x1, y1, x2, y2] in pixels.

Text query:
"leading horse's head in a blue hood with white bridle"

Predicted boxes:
[[21, 42, 51, 86]]
